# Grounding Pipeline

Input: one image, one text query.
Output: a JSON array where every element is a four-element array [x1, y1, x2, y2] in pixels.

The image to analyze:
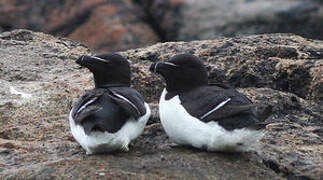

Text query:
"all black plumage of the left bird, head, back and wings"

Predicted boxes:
[[72, 54, 146, 134]]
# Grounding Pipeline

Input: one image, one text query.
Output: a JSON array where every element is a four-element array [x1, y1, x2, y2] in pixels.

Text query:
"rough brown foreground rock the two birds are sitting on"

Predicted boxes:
[[0, 30, 323, 179]]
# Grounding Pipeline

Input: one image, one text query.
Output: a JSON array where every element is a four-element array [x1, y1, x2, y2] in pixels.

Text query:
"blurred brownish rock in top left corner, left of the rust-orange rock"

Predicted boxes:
[[0, 0, 106, 36]]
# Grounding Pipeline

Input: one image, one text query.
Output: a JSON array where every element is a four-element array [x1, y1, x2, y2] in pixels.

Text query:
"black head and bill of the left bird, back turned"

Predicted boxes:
[[76, 53, 131, 88]]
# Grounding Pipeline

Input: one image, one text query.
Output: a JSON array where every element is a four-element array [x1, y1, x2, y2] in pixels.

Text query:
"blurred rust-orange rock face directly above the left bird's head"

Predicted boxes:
[[69, 3, 158, 52]]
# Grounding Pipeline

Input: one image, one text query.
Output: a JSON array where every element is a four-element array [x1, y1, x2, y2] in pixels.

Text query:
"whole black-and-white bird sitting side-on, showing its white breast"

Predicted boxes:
[[150, 54, 271, 151]]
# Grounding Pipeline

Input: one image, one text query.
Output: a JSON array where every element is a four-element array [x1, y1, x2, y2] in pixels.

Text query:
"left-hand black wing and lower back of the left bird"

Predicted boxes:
[[72, 89, 129, 134]]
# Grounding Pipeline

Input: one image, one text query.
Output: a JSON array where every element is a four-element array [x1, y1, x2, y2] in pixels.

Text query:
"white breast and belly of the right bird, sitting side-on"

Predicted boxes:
[[159, 89, 263, 151]]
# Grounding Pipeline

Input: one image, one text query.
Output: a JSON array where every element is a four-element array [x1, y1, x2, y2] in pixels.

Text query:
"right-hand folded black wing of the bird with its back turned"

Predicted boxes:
[[109, 87, 146, 119]]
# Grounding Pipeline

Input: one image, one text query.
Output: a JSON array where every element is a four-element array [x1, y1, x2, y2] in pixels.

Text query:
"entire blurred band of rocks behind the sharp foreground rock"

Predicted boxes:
[[0, 0, 323, 52]]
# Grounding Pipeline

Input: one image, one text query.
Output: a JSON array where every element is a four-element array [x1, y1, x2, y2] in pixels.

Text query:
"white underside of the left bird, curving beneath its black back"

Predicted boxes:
[[69, 103, 151, 154]]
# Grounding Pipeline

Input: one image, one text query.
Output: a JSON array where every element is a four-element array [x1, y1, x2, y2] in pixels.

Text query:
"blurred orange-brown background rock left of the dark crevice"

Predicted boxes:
[[0, 0, 158, 52]]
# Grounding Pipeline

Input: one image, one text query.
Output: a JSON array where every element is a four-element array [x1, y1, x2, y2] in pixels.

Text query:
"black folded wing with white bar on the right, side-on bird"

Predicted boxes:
[[179, 84, 257, 130]]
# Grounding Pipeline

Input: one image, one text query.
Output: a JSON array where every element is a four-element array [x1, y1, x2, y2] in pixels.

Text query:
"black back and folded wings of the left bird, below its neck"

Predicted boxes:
[[72, 87, 146, 134]]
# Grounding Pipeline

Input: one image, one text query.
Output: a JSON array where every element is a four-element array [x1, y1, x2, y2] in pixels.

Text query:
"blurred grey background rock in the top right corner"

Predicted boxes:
[[179, 0, 323, 40]]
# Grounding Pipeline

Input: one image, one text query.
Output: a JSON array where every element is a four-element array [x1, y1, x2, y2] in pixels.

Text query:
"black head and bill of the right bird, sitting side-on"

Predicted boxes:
[[150, 54, 208, 92]]
